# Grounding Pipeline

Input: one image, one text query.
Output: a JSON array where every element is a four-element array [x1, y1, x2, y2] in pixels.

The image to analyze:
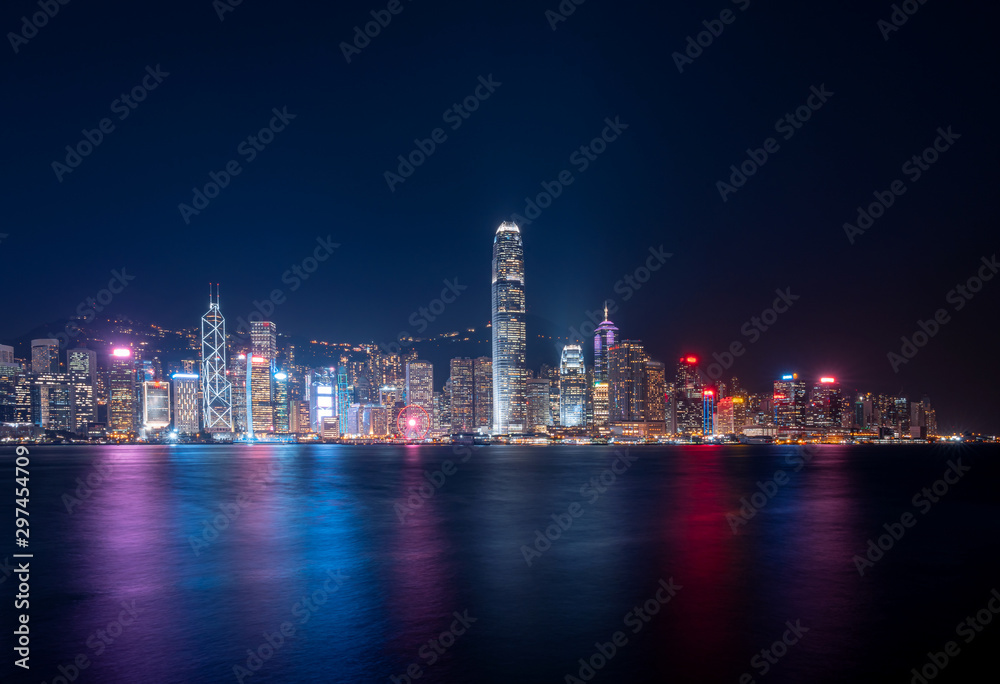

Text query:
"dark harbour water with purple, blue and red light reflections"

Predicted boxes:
[[0, 445, 1000, 684]]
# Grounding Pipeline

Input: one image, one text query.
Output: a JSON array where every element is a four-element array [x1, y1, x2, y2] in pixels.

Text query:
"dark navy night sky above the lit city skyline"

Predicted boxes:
[[0, 0, 1000, 430]]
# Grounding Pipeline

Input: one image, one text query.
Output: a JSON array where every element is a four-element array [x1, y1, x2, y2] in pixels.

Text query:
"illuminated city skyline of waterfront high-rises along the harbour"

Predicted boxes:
[[0, 223, 968, 442]]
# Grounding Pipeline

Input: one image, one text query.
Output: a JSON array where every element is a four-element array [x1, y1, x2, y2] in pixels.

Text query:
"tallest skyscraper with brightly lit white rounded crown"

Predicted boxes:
[[490, 222, 528, 434]]
